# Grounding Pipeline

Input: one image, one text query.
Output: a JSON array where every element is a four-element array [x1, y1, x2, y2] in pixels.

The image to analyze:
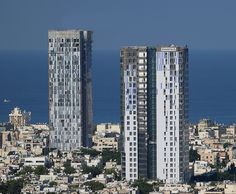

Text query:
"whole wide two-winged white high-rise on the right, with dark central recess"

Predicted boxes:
[[120, 45, 189, 183]]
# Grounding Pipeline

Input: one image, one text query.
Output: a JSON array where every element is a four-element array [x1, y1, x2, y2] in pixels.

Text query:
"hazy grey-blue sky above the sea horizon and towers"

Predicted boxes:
[[0, 0, 236, 50]]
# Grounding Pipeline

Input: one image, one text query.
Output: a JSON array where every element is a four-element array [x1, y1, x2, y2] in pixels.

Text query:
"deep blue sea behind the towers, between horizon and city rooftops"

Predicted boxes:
[[0, 50, 236, 124]]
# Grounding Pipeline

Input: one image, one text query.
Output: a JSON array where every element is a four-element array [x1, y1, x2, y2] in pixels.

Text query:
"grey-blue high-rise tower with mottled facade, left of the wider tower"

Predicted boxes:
[[48, 30, 92, 150]]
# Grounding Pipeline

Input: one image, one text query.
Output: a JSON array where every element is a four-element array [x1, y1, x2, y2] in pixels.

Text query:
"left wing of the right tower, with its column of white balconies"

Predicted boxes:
[[120, 47, 147, 180]]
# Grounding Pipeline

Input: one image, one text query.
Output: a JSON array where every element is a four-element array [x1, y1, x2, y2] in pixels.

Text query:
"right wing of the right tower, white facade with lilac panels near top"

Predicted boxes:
[[156, 45, 189, 183]]
